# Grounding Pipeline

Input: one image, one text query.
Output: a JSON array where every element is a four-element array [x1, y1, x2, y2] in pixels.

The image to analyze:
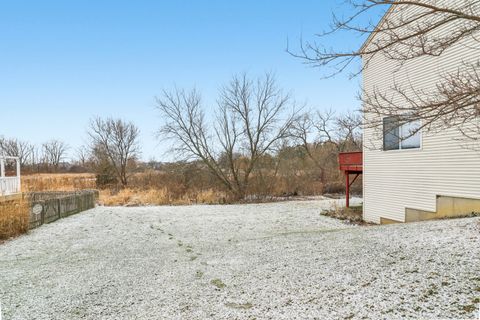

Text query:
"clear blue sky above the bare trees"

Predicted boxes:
[[0, 0, 368, 160]]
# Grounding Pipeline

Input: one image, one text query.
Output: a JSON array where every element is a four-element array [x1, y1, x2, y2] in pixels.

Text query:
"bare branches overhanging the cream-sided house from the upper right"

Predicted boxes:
[[289, 0, 480, 139]]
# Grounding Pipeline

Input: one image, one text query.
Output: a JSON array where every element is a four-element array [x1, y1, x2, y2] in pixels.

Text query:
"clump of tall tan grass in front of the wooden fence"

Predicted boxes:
[[0, 199, 30, 240]]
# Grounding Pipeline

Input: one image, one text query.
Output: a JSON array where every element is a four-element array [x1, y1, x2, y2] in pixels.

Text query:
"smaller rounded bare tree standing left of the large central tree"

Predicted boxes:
[[88, 118, 140, 187]]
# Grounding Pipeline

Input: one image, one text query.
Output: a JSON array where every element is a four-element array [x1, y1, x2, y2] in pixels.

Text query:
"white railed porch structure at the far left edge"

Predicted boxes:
[[0, 156, 21, 197]]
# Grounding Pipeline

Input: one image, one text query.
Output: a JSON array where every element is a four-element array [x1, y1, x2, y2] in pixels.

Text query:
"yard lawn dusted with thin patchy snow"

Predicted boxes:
[[0, 200, 480, 319]]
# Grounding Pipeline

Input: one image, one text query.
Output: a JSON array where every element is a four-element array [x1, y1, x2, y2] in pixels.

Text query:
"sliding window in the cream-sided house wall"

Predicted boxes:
[[383, 117, 421, 151]]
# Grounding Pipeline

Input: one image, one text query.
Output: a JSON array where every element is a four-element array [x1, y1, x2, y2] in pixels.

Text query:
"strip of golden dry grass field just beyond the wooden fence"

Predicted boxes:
[[21, 173, 96, 192]]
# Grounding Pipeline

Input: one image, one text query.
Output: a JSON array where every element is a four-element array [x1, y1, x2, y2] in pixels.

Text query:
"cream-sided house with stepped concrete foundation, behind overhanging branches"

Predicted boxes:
[[362, 3, 480, 223]]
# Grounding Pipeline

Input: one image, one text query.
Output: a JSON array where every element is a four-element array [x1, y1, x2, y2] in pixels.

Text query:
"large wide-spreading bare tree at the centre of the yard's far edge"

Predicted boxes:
[[157, 74, 296, 200]]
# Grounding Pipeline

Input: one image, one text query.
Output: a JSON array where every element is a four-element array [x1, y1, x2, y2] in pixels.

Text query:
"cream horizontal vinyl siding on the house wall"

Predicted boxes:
[[363, 1, 480, 223]]
